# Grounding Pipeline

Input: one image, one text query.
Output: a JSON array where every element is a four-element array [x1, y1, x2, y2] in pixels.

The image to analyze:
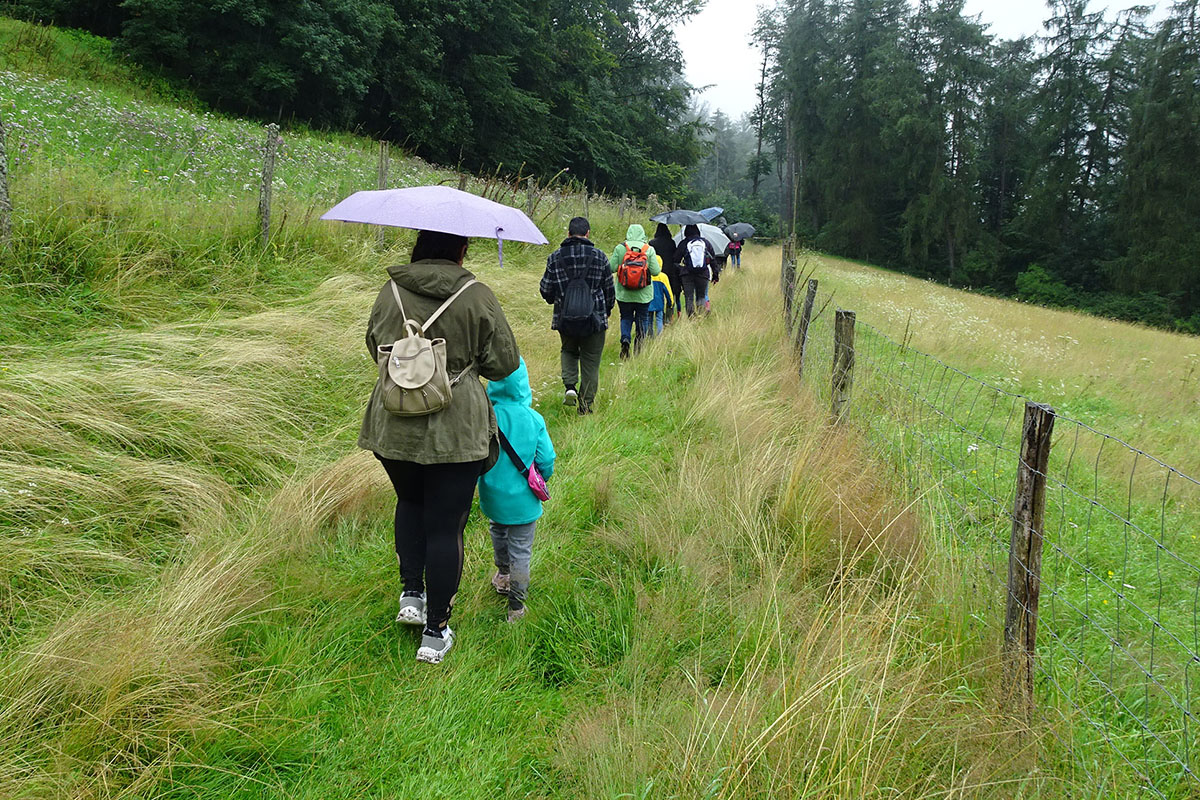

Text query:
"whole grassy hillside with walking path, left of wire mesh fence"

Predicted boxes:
[[0, 22, 1190, 800]]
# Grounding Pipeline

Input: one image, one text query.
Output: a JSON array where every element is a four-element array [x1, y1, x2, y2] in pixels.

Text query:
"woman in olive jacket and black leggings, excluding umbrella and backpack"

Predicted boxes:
[[359, 230, 521, 663]]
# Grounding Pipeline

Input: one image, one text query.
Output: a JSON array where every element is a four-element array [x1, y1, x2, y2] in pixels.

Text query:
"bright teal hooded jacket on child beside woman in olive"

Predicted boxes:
[[479, 359, 554, 525]]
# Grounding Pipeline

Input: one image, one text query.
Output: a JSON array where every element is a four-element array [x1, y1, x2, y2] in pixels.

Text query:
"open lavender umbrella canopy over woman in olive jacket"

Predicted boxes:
[[320, 186, 550, 245]]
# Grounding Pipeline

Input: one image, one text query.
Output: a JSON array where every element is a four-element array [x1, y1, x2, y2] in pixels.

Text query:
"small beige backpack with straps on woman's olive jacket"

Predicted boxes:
[[376, 279, 479, 416]]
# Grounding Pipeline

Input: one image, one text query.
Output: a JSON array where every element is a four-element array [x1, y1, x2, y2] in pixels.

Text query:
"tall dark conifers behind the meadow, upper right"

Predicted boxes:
[[751, 0, 1200, 333]]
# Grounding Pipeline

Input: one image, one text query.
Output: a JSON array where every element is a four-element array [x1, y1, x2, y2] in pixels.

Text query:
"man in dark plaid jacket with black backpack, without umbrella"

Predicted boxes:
[[539, 217, 616, 414]]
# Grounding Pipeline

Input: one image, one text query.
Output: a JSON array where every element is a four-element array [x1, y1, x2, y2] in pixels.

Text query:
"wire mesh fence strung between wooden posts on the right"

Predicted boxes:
[[781, 247, 1200, 796]]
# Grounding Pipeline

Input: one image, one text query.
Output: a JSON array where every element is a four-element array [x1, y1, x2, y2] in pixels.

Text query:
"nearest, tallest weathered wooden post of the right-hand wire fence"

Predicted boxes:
[[1003, 402, 1055, 715]]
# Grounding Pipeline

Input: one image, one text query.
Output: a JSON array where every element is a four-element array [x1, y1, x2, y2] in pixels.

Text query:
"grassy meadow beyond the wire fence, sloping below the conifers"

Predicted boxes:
[[800, 248, 1200, 792]]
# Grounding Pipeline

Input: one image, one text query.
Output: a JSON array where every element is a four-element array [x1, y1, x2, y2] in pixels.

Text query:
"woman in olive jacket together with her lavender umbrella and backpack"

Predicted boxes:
[[323, 186, 546, 663]]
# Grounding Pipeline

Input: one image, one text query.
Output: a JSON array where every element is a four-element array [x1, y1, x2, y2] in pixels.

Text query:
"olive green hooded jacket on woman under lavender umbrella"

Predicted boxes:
[[359, 259, 521, 464]]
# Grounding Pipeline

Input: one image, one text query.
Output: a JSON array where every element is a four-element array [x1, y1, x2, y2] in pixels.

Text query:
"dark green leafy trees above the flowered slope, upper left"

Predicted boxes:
[[6, 0, 702, 197]]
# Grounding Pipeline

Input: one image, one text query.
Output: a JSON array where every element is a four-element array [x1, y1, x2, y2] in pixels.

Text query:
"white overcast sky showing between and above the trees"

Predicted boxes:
[[676, 0, 1165, 119]]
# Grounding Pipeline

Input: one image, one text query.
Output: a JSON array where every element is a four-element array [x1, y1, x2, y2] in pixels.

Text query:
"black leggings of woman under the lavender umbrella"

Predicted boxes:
[[376, 453, 484, 628]]
